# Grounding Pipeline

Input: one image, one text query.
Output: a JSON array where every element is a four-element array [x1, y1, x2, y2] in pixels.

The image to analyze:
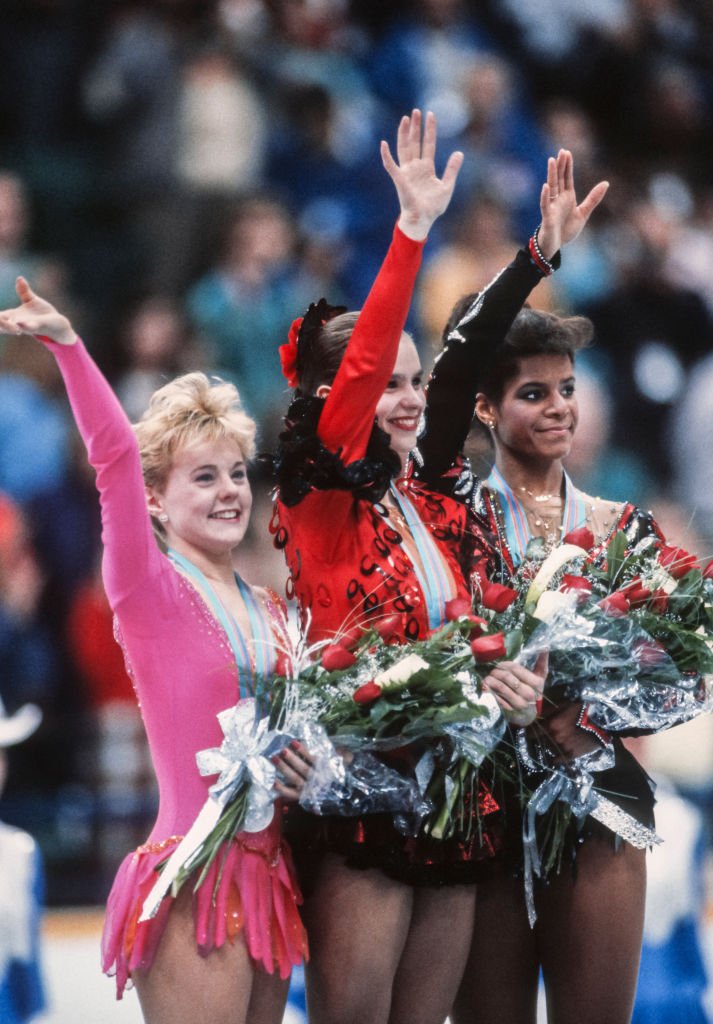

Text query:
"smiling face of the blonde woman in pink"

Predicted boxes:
[[149, 437, 252, 558]]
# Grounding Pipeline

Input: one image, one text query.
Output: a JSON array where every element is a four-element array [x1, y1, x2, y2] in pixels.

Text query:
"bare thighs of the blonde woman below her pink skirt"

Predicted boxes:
[[132, 886, 288, 1024]]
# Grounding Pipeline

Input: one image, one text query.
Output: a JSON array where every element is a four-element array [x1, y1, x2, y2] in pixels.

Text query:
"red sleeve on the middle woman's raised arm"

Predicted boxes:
[[319, 227, 425, 462]]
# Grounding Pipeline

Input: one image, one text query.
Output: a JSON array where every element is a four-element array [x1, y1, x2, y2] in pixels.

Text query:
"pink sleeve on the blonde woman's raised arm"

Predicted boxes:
[[45, 339, 163, 610]]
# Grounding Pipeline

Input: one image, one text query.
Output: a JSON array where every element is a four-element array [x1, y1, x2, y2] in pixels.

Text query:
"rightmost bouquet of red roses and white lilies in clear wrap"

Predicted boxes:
[[484, 528, 713, 733]]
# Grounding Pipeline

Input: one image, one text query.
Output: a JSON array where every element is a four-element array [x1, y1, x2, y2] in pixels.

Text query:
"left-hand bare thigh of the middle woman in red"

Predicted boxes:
[[303, 854, 413, 1024]]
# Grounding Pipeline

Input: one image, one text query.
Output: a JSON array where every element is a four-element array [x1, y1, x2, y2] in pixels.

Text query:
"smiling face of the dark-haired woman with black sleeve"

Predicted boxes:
[[485, 355, 578, 465]]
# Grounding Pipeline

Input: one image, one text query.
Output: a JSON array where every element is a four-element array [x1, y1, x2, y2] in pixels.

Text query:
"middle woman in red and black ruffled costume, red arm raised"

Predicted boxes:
[[271, 111, 543, 1024]]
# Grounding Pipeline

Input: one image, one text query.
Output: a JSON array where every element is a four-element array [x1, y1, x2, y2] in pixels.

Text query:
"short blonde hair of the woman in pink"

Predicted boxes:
[[134, 373, 256, 529]]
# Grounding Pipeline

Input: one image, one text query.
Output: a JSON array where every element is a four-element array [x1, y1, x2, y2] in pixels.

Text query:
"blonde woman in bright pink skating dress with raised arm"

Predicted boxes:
[[0, 278, 308, 1024]]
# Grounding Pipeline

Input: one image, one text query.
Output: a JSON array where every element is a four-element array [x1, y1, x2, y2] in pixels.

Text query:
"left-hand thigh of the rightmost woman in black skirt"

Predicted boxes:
[[451, 873, 536, 1024]]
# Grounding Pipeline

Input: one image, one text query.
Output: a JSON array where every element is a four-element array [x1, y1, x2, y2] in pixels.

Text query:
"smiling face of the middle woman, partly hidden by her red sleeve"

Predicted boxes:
[[376, 334, 426, 466]]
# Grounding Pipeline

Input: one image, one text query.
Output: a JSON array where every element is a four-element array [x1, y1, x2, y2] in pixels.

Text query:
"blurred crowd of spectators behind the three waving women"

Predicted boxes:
[[0, 0, 713, 1015]]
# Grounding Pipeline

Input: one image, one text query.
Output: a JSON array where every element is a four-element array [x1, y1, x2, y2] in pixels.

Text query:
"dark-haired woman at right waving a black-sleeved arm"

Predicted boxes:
[[419, 150, 662, 1024]]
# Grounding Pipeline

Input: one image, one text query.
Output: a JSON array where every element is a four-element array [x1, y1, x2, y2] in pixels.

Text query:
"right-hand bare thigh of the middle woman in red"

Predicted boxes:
[[389, 886, 475, 1024]]
